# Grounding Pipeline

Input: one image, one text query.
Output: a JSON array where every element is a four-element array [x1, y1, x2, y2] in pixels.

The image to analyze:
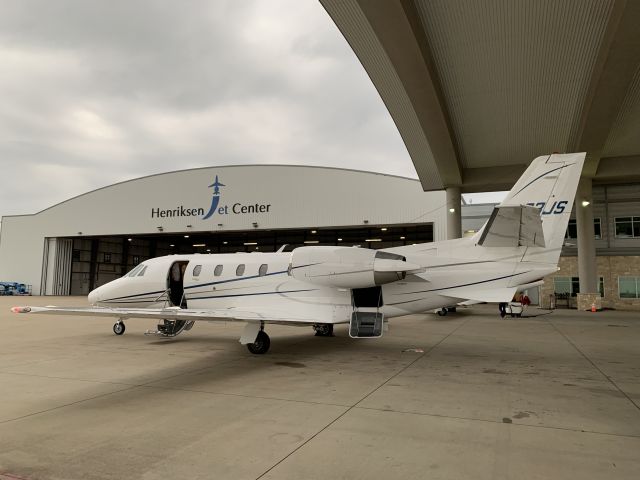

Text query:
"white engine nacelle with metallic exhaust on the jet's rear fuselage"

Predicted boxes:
[[289, 246, 412, 288]]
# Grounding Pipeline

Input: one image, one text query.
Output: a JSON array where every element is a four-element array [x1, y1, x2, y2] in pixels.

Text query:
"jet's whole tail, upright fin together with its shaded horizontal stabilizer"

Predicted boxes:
[[478, 153, 586, 264]]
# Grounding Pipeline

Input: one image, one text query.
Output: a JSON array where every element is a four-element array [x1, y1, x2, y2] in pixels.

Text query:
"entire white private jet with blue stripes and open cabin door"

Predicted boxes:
[[12, 153, 585, 354]]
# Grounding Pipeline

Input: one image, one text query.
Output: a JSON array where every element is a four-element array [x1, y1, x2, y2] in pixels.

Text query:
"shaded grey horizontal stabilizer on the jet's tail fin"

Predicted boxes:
[[478, 205, 545, 247]]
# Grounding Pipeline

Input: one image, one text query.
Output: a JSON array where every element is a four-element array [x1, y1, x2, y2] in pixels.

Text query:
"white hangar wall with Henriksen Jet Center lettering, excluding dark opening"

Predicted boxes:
[[0, 165, 447, 293]]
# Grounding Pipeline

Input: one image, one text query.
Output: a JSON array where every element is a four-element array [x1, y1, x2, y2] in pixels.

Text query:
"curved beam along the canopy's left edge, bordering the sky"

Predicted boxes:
[[320, 0, 462, 190]]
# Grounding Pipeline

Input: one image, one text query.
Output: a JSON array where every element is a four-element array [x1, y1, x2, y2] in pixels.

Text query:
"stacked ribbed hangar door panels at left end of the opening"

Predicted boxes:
[[40, 238, 73, 295]]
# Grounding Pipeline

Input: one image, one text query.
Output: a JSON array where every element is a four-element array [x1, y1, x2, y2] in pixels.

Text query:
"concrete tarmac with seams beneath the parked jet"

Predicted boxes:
[[0, 297, 640, 480]]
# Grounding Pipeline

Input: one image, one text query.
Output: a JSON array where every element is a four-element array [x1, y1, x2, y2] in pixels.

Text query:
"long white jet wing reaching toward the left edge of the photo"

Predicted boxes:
[[11, 306, 334, 325]]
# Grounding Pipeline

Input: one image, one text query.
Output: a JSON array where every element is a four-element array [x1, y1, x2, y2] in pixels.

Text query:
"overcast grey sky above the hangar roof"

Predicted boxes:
[[0, 0, 415, 215]]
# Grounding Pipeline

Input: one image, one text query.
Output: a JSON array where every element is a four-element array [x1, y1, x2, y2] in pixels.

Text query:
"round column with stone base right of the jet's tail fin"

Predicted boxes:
[[575, 177, 601, 310]]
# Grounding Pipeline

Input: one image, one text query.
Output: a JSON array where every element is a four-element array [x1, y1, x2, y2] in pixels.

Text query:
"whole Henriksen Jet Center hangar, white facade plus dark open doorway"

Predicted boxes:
[[0, 165, 448, 295]]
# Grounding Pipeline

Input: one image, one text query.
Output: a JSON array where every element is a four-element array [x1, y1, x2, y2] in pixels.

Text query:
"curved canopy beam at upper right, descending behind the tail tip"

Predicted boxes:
[[569, 0, 640, 177]]
